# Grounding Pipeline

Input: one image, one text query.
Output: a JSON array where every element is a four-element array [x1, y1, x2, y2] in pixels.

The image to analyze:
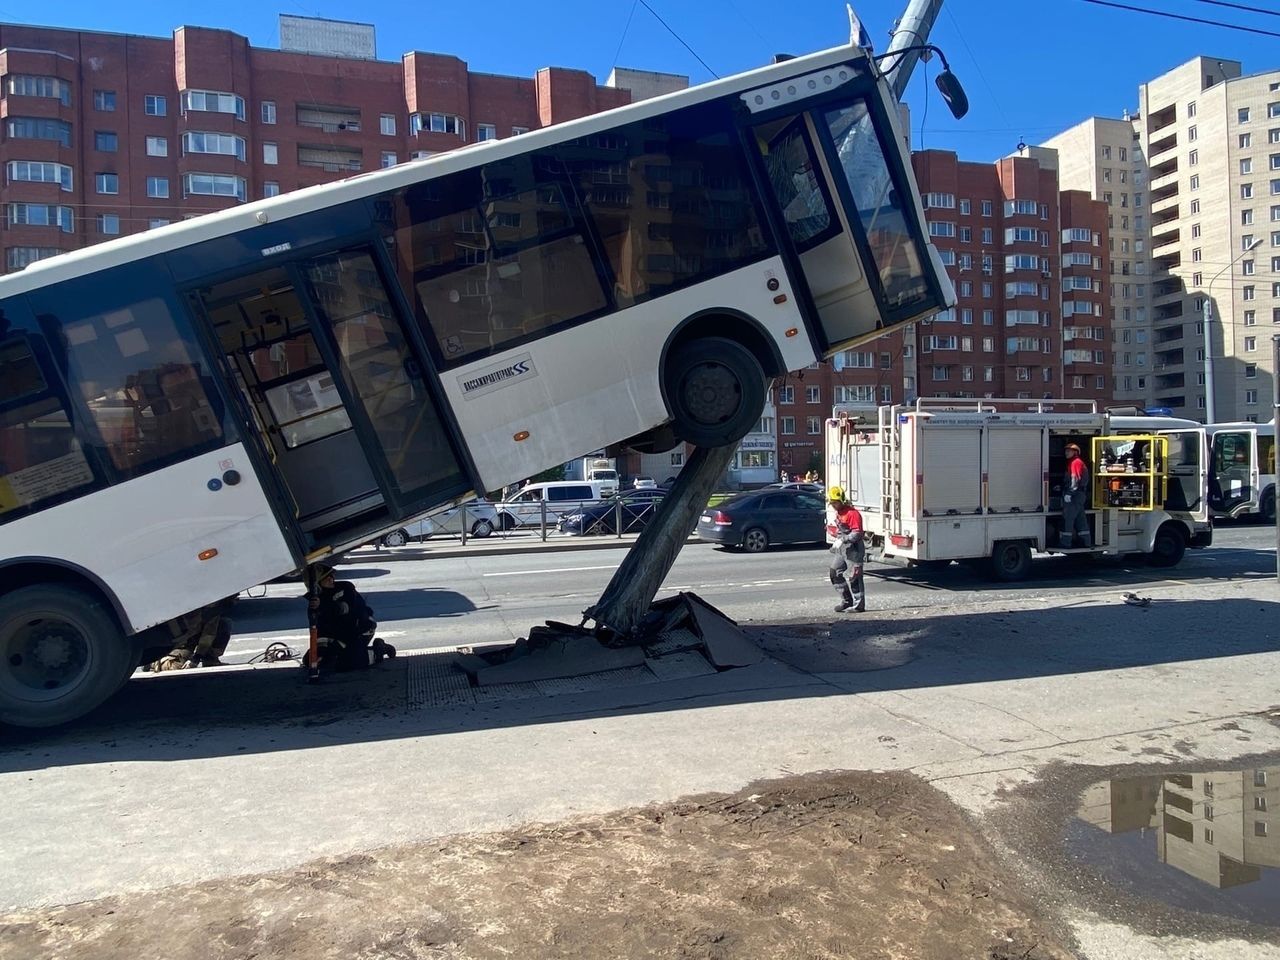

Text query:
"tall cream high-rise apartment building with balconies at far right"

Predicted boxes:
[[1046, 56, 1280, 421]]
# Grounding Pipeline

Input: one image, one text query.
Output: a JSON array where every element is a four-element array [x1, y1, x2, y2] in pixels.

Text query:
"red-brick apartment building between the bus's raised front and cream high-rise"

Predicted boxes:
[[774, 150, 1114, 474]]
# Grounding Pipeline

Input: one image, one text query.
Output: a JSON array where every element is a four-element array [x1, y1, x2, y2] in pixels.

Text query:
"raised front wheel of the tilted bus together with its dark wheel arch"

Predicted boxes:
[[660, 311, 783, 447]]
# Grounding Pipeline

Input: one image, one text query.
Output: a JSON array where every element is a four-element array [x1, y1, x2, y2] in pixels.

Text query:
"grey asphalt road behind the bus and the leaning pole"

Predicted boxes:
[[227, 522, 1275, 662]]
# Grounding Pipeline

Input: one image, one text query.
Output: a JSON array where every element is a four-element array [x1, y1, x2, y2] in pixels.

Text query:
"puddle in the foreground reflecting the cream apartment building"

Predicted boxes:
[[1065, 767, 1280, 927]]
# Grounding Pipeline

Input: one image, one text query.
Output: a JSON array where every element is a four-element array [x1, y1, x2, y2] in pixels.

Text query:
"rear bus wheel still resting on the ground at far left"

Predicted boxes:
[[0, 584, 136, 727]]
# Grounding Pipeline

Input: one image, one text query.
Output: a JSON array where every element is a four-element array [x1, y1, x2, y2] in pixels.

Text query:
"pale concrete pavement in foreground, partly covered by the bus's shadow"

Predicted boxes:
[[0, 576, 1280, 960]]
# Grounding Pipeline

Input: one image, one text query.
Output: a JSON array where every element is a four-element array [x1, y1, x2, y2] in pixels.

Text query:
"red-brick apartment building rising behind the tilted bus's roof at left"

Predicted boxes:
[[0, 18, 637, 270]]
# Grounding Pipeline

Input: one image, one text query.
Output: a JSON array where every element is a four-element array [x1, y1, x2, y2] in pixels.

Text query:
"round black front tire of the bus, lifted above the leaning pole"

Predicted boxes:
[[664, 337, 764, 447]]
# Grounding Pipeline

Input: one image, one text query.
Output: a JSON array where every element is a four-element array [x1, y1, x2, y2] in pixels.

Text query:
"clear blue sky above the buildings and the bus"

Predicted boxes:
[[12, 0, 1280, 160]]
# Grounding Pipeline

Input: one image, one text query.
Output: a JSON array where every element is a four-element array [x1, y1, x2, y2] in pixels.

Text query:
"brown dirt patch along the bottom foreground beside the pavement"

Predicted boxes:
[[0, 773, 1073, 960]]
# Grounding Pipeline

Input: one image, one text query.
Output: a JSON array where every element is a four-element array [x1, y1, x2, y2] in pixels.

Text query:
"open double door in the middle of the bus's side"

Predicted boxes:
[[192, 247, 470, 556]]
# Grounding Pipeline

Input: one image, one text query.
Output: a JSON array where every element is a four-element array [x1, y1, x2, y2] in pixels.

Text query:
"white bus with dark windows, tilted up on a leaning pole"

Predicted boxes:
[[0, 39, 954, 726]]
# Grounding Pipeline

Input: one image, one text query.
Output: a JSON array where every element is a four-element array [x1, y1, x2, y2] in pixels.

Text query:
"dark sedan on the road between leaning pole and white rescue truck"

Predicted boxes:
[[698, 488, 827, 553]]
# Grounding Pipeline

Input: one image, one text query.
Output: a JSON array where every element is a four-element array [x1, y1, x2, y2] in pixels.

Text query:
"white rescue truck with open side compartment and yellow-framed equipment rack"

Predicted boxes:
[[826, 398, 1213, 581]]
